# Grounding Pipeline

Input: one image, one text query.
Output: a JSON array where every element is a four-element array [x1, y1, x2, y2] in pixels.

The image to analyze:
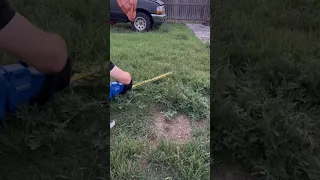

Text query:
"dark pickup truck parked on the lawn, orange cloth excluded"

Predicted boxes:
[[110, 0, 166, 31]]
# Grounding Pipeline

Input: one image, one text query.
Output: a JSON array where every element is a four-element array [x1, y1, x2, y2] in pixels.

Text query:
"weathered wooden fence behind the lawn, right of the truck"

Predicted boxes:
[[162, 0, 210, 22]]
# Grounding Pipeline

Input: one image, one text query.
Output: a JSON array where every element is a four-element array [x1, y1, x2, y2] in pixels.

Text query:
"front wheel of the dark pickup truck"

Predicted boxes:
[[131, 12, 151, 32]]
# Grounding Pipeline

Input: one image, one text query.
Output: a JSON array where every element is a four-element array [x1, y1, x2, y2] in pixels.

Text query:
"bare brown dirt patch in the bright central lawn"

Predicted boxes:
[[151, 113, 192, 146]]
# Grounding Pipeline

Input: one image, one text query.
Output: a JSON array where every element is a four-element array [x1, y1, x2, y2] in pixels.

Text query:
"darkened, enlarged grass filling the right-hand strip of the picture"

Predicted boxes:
[[211, 0, 320, 180]]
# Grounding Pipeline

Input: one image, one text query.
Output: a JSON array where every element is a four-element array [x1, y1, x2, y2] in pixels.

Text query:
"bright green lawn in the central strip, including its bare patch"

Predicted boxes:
[[110, 24, 210, 180]]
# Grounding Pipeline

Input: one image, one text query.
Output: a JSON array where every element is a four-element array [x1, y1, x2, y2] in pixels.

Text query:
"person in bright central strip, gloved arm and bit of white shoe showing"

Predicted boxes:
[[110, 61, 132, 128]]
